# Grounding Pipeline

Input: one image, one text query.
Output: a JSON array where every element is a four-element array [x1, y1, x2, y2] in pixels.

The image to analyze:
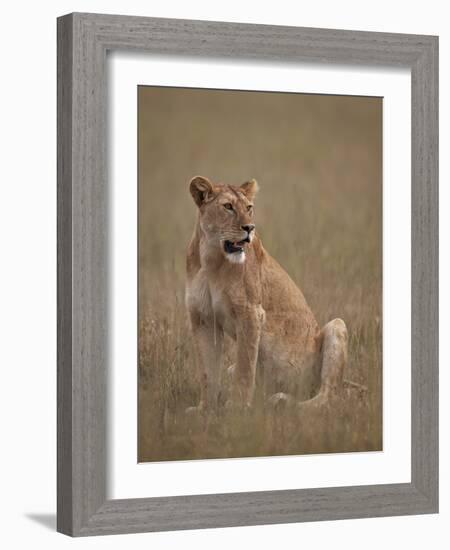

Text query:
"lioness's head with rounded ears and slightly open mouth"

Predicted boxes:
[[189, 176, 258, 263]]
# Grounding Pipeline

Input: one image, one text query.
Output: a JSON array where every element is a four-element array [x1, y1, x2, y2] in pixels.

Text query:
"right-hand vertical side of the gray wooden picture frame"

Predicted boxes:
[[411, 36, 439, 510]]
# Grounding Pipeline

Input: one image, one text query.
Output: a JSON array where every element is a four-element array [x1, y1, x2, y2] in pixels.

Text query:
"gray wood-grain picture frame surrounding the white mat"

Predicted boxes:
[[57, 13, 438, 536]]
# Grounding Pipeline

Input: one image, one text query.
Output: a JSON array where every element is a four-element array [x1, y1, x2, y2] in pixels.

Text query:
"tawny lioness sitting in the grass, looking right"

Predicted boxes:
[[186, 176, 347, 410]]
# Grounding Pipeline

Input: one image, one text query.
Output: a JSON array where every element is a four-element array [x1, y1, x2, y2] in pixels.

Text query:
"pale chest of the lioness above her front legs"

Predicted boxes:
[[186, 270, 236, 338]]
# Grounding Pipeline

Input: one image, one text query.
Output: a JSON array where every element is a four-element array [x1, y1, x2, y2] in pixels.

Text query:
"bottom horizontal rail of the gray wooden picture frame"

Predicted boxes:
[[78, 484, 432, 536]]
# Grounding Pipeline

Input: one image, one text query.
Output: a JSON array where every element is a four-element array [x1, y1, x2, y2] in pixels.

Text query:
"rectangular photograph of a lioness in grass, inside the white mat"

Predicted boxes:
[[136, 86, 383, 463]]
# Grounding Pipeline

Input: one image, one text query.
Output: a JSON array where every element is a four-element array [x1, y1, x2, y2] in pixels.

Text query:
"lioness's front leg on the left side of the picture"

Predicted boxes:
[[188, 315, 223, 412]]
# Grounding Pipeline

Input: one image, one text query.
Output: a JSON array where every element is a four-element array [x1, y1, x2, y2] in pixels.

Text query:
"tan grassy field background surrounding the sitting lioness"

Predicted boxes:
[[138, 87, 382, 462]]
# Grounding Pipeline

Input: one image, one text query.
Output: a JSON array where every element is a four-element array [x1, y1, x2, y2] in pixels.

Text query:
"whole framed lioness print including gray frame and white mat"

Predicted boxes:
[[58, 14, 438, 536]]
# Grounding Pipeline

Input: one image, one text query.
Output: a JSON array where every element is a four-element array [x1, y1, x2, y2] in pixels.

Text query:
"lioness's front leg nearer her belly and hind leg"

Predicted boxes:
[[233, 308, 263, 407]]
